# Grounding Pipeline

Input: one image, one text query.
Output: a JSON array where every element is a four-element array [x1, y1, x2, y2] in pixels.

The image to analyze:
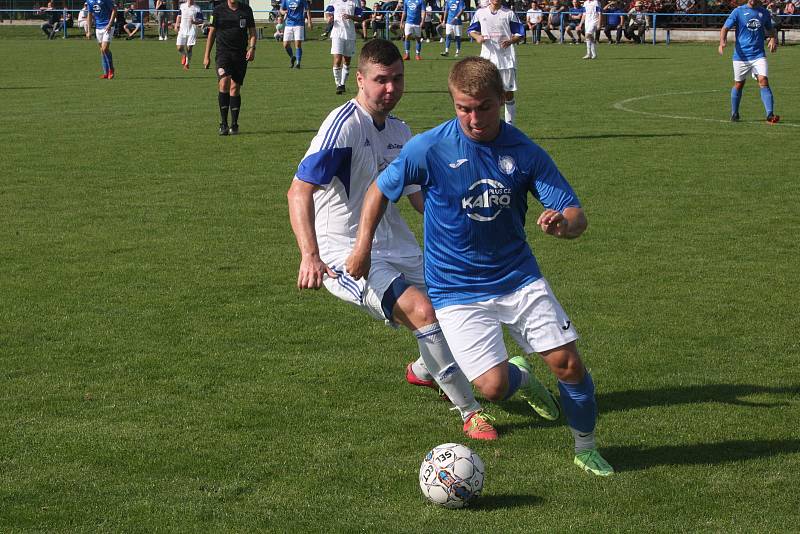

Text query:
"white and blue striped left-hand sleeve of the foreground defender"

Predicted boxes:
[[295, 103, 360, 190]]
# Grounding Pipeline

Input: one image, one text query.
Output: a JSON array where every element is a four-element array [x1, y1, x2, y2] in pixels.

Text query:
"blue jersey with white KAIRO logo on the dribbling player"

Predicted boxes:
[[377, 119, 580, 309]]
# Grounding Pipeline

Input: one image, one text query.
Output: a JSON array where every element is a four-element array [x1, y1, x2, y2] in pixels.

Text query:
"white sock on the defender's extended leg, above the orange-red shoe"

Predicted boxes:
[[414, 323, 481, 421]]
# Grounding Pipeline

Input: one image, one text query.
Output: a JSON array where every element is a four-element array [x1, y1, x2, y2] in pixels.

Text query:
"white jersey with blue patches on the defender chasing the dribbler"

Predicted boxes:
[[295, 99, 422, 265]]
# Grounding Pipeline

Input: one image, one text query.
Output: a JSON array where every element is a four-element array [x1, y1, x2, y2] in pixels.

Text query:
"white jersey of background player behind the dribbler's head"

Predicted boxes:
[[467, 6, 525, 69]]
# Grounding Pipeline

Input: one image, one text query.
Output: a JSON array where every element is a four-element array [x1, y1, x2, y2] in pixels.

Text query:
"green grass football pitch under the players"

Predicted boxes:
[[0, 28, 800, 533]]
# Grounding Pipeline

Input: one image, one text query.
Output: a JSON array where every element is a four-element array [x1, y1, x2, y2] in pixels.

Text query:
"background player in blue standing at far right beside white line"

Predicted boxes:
[[719, 0, 780, 124]]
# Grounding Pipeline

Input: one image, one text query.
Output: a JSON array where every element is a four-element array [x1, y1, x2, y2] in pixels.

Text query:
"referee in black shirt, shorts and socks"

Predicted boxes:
[[203, 0, 256, 135]]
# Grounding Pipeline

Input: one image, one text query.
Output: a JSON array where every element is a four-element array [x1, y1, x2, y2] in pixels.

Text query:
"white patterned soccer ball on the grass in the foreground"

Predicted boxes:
[[419, 443, 484, 508]]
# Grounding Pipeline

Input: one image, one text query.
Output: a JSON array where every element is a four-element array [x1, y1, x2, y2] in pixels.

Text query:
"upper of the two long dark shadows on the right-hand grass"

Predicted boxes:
[[597, 384, 800, 413]]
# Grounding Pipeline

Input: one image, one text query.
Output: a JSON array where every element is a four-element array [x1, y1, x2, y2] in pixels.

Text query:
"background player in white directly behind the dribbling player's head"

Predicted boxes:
[[467, 0, 525, 124]]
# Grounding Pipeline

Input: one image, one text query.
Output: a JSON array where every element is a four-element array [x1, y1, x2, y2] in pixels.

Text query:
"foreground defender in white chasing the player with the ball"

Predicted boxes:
[[288, 39, 497, 439]]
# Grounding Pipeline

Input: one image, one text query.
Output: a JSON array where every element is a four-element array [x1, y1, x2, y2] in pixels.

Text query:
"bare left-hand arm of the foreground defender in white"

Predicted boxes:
[[286, 179, 337, 289]]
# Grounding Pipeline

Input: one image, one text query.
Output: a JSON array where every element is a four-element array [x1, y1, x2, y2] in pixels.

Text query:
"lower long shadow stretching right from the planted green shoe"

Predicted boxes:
[[603, 439, 800, 471]]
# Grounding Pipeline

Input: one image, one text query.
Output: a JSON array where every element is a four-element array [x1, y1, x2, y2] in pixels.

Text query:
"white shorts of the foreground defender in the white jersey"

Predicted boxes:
[[323, 256, 428, 326]]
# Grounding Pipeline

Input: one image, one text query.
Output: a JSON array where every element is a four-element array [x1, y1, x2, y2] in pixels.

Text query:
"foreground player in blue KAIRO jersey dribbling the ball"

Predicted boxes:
[[346, 57, 614, 476]]
